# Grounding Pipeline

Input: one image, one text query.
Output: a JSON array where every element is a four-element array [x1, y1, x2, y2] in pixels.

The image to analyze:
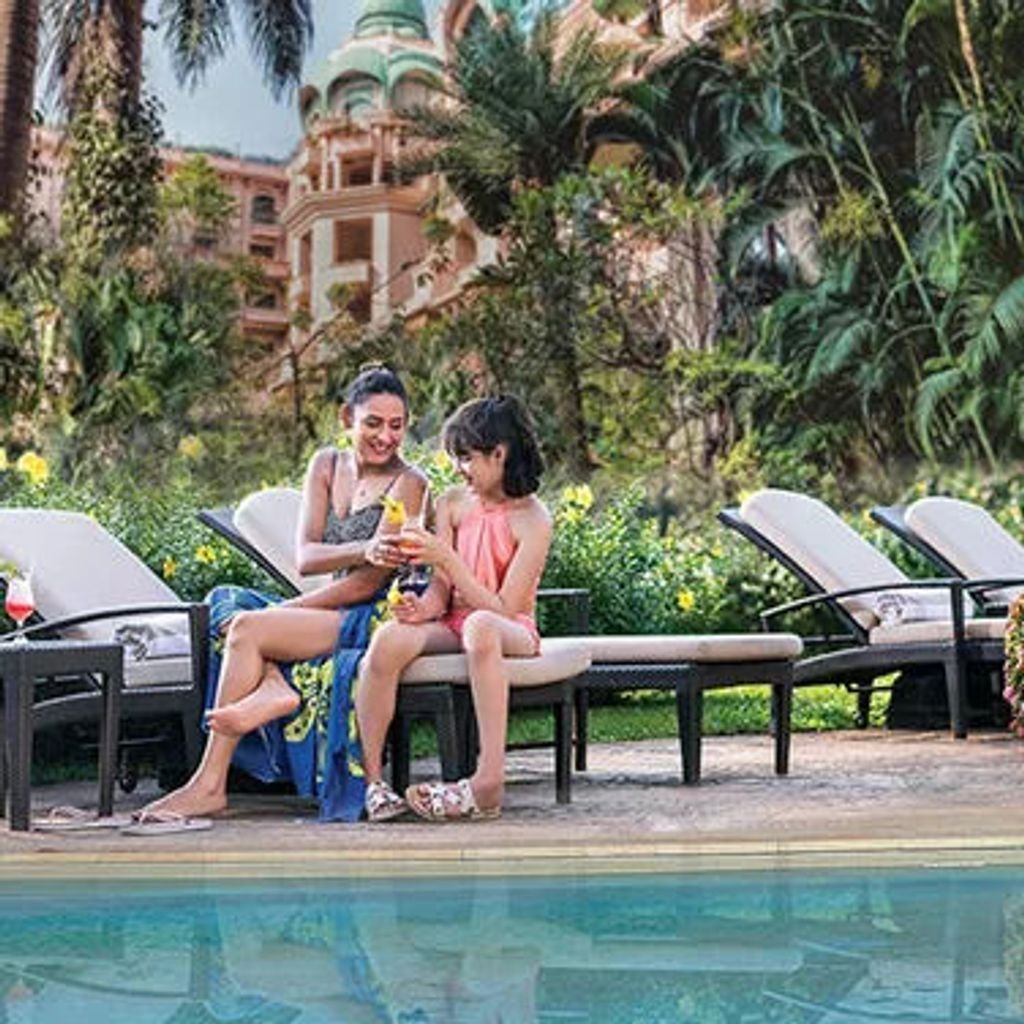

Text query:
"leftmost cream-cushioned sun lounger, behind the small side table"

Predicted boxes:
[[0, 509, 208, 771]]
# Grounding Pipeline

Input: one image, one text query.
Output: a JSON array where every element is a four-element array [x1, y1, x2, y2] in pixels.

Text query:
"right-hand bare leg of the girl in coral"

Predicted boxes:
[[462, 611, 537, 808]]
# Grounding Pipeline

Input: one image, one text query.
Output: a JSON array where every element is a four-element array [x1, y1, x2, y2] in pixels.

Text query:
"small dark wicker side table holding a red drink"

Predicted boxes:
[[0, 640, 124, 831]]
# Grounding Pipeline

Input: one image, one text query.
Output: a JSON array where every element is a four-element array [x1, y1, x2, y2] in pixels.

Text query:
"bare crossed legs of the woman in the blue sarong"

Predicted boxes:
[[145, 608, 342, 815]]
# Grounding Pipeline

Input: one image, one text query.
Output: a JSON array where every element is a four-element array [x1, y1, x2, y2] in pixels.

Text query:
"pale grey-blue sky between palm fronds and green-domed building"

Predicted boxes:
[[145, 0, 438, 160]]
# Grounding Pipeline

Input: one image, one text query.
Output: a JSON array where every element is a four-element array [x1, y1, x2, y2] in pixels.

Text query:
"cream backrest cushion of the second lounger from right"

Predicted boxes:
[[740, 487, 907, 629]]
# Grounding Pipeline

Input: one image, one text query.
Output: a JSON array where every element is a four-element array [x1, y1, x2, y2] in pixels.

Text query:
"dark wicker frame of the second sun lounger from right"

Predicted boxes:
[[718, 509, 1024, 739]]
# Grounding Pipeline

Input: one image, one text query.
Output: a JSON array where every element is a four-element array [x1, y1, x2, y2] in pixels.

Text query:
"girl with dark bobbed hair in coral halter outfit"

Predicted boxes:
[[355, 397, 551, 821]]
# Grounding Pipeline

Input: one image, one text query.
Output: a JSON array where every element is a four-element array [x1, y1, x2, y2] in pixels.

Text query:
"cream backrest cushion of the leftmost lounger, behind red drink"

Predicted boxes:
[[0, 509, 180, 641]]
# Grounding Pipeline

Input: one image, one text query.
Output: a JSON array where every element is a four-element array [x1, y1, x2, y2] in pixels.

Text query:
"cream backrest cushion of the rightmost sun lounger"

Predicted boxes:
[[904, 498, 1024, 604]]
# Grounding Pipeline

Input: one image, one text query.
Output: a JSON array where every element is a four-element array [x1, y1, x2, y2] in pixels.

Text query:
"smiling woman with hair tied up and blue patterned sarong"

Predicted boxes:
[[140, 366, 427, 821]]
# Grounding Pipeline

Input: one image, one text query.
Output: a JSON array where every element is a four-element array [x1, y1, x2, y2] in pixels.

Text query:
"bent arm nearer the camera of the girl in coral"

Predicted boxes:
[[405, 499, 552, 616]]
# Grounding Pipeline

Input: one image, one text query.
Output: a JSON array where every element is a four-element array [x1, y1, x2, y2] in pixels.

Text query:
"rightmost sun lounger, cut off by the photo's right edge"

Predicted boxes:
[[871, 497, 1024, 613]]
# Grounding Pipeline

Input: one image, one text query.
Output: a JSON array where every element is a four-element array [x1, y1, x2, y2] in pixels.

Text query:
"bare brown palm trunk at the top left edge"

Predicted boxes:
[[0, 0, 39, 215]]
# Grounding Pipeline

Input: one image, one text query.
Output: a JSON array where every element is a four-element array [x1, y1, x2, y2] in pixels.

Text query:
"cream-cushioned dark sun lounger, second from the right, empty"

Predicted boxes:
[[719, 488, 1005, 737]]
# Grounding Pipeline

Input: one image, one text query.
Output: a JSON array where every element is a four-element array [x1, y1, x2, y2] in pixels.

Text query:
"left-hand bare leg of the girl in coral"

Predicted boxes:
[[355, 622, 459, 783]]
